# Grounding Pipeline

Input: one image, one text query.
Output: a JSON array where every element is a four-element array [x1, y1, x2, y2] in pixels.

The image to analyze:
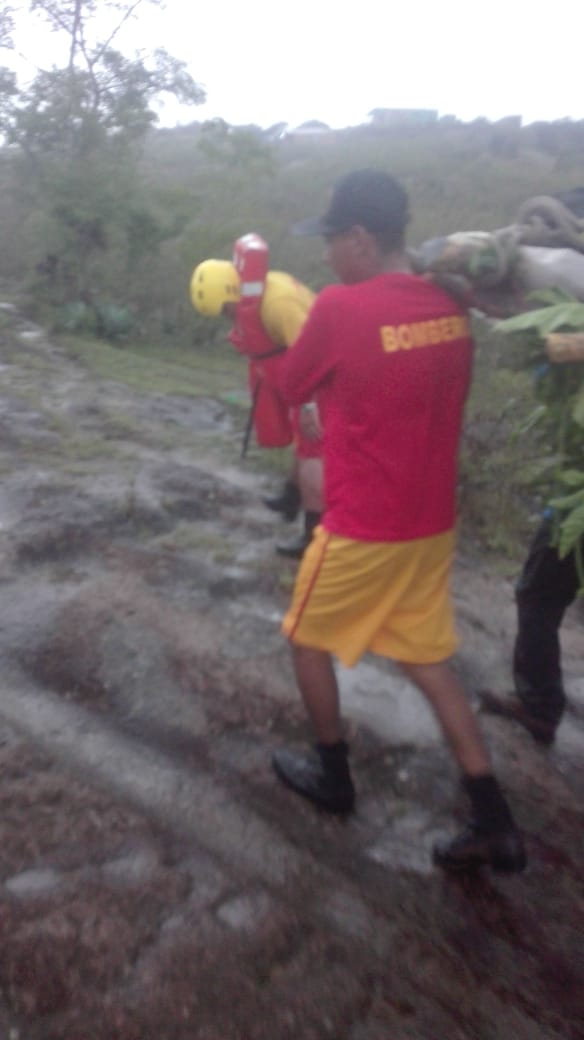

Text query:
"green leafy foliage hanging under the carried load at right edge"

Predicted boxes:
[[499, 290, 584, 595]]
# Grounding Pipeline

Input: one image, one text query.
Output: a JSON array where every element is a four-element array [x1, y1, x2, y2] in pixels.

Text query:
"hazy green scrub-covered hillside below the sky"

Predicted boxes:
[[0, 119, 584, 345]]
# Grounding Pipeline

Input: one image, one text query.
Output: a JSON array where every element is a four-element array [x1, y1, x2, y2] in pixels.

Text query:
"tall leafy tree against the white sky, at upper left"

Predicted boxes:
[[0, 0, 205, 318]]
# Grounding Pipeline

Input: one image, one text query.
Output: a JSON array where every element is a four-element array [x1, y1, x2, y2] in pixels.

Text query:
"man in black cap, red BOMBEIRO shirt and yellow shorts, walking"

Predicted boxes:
[[273, 170, 526, 872]]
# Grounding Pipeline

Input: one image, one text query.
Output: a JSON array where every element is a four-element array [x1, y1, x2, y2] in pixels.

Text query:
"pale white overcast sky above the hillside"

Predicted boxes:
[[0, 0, 584, 127]]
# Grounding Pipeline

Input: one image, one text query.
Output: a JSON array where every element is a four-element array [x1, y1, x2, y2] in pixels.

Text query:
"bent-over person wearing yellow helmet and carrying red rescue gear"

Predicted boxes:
[[190, 246, 322, 558]]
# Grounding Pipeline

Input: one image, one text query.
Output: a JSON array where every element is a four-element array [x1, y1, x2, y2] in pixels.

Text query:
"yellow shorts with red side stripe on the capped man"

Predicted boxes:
[[282, 527, 458, 667]]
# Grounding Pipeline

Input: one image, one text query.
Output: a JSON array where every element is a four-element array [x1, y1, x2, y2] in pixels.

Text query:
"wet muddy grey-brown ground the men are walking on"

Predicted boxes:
[[0, 295, 584, 1040]]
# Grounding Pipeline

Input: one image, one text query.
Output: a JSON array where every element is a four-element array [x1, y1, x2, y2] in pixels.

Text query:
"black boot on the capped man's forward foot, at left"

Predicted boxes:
[[272, 740, 354, 814]]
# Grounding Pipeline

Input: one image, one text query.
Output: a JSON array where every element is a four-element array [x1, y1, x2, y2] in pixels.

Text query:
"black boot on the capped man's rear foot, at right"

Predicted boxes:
[[433, 775, 527, 874]]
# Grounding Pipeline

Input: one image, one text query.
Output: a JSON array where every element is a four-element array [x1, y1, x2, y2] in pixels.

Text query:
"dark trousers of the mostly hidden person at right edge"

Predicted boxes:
[[513, 520, 579, 723]]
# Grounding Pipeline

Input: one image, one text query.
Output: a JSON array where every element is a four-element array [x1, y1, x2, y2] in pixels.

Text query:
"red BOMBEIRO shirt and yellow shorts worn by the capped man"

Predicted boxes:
[[282, 274, 472, 665]]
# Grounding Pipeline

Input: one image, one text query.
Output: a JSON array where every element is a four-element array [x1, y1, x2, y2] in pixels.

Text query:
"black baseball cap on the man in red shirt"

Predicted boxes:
[[292, 170, 408, 236]]
